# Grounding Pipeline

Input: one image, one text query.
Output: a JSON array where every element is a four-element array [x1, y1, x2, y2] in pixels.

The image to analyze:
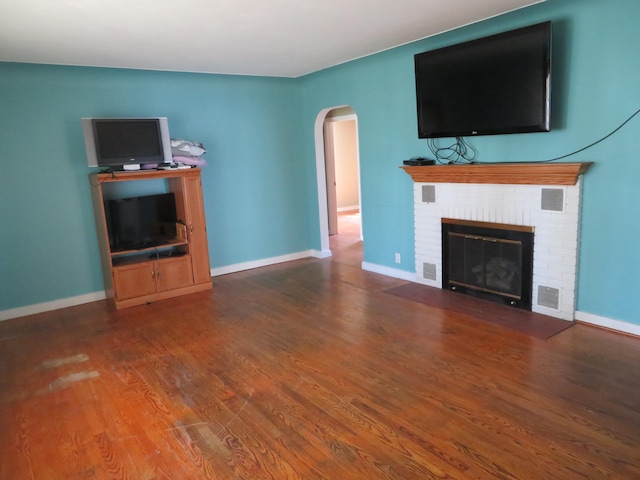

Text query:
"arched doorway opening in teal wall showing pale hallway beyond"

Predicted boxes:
[[315, 106, 363, 257]]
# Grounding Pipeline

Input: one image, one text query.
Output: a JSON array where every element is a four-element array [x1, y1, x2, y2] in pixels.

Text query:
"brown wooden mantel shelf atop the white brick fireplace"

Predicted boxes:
[[400, 162, 593, 185]]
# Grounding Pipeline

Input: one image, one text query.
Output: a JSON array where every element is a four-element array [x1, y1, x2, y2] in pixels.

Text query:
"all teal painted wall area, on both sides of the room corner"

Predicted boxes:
[[0, 0, 640, 324]]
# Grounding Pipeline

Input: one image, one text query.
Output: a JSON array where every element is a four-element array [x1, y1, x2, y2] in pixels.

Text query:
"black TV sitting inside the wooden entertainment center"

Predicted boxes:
[[109, 193, 177, 251]]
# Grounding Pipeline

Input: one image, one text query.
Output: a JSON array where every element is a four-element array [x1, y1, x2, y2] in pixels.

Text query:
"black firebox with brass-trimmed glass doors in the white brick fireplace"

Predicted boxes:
[[442, 218, 534, 310]]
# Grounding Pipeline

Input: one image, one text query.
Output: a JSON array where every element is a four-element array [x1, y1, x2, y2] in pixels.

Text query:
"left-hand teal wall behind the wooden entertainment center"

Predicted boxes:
[[0, 63, 310, 310]]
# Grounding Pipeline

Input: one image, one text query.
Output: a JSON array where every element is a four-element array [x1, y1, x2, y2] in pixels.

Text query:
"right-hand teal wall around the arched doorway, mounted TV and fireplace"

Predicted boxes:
[[301, 0, 640, 324]]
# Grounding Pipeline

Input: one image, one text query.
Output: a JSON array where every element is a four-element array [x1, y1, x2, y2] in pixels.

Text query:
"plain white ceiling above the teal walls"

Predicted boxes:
[[0, 0, 544, 77]]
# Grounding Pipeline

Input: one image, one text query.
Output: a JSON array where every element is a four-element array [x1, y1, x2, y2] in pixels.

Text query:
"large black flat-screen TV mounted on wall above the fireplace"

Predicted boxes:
[[414, 22, 551, 138]]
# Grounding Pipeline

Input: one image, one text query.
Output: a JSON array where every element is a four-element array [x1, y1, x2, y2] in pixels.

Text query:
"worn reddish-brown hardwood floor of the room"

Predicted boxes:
[[0, 216, 640, 480]]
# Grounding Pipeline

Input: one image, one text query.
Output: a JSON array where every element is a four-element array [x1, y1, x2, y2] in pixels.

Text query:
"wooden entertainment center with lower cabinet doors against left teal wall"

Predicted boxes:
[[89, 168, 212, 309]]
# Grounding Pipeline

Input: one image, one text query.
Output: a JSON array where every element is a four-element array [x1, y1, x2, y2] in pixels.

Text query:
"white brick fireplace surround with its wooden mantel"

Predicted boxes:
[[403, 163, 591, 320]]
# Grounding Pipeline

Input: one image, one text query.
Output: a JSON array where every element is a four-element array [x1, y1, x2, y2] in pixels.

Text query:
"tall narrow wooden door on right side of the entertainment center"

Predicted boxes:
[[183, 175, 211, 284]]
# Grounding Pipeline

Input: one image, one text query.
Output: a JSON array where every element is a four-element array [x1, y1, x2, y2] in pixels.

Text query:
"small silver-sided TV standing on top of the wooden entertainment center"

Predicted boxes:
[[82, 117, 172, 170]]
